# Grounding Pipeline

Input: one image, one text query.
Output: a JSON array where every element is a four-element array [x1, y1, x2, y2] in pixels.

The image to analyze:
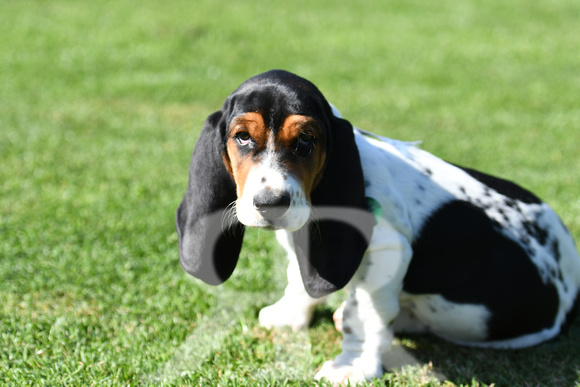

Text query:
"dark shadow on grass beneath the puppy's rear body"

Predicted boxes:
[[390, 319, 580, 386]]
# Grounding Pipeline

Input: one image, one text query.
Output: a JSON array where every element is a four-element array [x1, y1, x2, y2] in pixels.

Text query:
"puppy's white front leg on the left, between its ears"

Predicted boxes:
[[259, 230, 326, 331]]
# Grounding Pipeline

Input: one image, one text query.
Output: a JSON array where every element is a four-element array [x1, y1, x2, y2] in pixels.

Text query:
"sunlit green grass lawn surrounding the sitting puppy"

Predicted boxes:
[[0, 0, 580, 386]]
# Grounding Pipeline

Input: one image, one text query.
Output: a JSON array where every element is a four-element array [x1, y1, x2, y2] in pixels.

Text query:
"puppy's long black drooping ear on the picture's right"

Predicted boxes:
[[294, 116, 376, 297]]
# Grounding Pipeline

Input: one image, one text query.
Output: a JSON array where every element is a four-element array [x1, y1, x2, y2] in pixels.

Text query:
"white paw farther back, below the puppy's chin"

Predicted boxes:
[[258, 299, 314, 331]]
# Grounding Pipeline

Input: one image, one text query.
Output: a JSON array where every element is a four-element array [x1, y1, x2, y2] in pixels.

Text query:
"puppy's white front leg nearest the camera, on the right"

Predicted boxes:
[[316, 230, 411, 384]]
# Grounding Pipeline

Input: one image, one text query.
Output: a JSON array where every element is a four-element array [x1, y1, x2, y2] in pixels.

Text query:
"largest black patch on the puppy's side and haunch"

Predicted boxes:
[[403, 200, 559, 340]]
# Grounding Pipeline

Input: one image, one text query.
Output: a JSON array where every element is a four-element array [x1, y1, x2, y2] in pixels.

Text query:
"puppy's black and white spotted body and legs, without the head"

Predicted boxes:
[[260, 121, 580, 382]]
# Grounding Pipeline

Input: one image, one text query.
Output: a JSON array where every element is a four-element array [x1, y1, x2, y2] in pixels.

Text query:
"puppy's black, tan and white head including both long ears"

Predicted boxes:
[[176, 70, 373, 297]]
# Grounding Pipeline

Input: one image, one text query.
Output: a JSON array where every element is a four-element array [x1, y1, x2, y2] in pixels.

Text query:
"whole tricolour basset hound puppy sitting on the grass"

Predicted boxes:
[[176, 70, 580, 383]]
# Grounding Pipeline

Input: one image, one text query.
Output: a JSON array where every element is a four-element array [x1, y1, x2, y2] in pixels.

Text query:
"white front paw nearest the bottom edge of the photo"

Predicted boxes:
[[315, 354, 383, 385]]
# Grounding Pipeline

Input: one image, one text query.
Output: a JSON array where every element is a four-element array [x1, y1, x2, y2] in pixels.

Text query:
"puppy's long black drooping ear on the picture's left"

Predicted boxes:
[[175, 111, 244, 285]]
